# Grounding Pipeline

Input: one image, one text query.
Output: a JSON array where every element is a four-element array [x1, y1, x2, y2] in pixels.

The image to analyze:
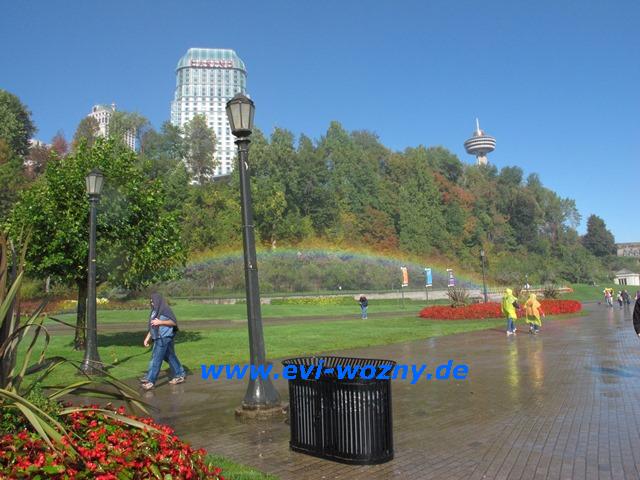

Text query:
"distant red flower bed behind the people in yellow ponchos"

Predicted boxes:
[[420, 300, 582, 320]]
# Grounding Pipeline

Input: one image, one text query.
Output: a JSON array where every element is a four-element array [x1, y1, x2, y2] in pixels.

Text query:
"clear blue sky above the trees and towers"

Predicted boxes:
[[0, 0, 640, 242]]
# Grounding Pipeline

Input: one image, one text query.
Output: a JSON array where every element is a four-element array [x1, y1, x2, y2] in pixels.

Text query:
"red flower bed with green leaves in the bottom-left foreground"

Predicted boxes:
[[0, 409, 224, 480]]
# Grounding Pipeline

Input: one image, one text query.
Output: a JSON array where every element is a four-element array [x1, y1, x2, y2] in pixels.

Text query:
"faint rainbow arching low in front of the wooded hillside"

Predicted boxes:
[[187, 241, 482, 288]]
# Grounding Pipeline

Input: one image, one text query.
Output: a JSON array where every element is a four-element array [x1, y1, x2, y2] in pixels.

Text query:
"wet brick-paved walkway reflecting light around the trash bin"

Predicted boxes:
[[147, 305, 640, 480]]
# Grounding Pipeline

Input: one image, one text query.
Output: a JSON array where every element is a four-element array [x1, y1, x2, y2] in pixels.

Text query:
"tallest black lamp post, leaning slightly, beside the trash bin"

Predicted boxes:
[[227, 93, 280, 410]]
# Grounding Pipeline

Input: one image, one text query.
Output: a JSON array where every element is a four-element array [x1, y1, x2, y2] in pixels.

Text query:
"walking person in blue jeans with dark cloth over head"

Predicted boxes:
[[142, 293, 186, 390]]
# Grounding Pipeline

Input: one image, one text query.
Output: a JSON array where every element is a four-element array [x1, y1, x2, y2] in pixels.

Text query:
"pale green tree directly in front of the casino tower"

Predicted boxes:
[[184, 115, 216, 185]]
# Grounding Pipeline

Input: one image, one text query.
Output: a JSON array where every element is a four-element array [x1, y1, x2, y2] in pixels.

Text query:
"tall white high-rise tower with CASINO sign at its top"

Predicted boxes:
[[171, 48, 247, 176]]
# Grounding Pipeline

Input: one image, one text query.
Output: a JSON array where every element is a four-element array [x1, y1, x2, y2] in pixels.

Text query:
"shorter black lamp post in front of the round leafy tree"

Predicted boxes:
[[82, 168, 104, 375]]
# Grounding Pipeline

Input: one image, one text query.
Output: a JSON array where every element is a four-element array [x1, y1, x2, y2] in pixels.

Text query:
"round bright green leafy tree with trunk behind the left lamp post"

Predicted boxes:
[[11, 139, 184, 349]]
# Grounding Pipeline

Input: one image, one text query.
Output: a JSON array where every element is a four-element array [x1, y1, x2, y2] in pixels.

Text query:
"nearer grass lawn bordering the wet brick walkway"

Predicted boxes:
[[25, 315, 503, 384]]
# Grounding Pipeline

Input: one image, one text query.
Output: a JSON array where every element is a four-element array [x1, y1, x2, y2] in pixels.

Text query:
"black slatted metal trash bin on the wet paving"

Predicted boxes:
[[282, 356, 395, 465]]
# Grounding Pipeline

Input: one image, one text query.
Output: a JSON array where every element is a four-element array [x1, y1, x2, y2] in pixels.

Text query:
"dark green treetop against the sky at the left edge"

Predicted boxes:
[[0, 89, 36, 156]]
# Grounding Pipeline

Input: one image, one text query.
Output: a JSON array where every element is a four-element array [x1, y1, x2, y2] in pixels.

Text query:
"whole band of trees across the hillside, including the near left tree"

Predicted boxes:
[[0, 90, 615, 342]]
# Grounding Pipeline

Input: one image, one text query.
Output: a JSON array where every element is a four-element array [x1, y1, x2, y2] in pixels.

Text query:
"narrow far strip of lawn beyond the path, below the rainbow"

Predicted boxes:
[[47, 300, 435, 329]]
